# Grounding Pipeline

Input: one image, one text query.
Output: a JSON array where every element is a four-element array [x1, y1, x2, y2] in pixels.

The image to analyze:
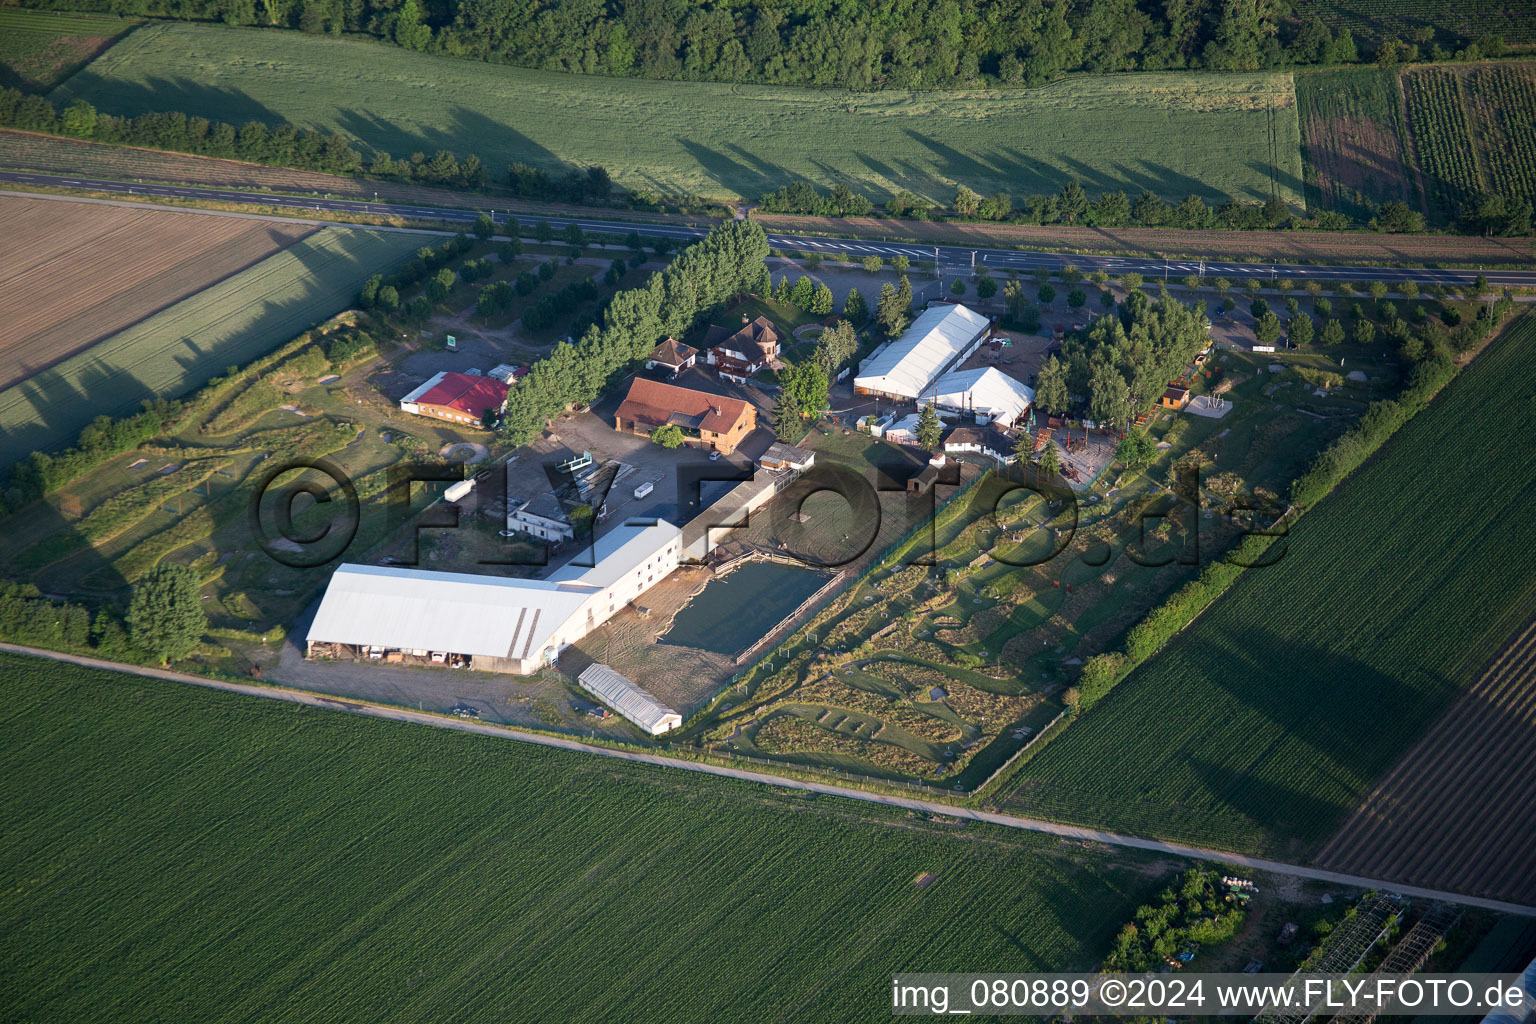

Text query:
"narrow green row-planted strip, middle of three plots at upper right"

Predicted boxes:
[[1402, 68, 1481, 218]]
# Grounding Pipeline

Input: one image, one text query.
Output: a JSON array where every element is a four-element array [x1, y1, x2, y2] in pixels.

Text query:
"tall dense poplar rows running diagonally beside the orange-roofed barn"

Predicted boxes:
[[501, 221, 768, 445]]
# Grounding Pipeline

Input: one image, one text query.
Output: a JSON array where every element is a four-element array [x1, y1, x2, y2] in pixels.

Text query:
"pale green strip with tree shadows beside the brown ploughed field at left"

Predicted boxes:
[[0, 227, 421, 462]]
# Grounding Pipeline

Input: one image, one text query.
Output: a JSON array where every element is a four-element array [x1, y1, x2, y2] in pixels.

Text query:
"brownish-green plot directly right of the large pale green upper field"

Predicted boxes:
[[1296, 68, 1421, 220]]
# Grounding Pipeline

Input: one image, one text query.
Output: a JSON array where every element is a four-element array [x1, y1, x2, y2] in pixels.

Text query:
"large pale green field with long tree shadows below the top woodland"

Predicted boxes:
[[52, 23, 1301, 206]]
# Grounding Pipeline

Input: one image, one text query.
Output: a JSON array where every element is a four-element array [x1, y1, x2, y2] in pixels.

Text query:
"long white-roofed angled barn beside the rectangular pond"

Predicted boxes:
[[306, 520, 682, 676]]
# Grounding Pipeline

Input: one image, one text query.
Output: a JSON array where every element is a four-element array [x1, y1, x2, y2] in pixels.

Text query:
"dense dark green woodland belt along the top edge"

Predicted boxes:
[[21, 0, 1504, 89]]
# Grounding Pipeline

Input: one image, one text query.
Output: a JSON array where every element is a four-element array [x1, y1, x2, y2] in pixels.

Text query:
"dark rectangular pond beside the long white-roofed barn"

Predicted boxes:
[[660, 562, 828, 654]]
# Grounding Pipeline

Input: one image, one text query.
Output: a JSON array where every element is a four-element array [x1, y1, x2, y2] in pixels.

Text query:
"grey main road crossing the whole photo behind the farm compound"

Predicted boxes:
[[0, 170, 1536, 287]]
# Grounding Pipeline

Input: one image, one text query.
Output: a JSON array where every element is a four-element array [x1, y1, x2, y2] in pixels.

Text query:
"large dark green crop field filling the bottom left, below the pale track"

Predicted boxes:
[[0, 656, 1166, 1024]]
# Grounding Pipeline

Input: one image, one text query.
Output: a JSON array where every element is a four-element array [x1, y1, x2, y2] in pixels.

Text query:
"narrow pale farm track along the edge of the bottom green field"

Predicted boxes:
[[0, 643, 1536, 917]]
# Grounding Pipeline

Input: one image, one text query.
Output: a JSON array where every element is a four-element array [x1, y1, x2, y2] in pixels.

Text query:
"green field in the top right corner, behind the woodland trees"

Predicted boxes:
[[1295, 0, 1536, 43]]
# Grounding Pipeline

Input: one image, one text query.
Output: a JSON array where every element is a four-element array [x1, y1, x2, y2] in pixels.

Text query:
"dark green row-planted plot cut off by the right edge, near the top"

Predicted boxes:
[[1462, 61, 1536, 198]]
